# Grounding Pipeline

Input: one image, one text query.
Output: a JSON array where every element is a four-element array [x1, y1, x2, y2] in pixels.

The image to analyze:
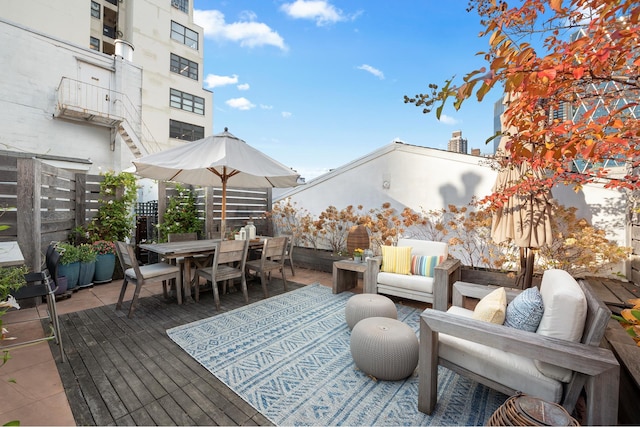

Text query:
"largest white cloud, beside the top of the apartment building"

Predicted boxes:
[[193, 9, 288, 51]]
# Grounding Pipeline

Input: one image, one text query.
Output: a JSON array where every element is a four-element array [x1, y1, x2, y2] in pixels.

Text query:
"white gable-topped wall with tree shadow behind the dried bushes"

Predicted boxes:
[[274, 142, 629, 246]]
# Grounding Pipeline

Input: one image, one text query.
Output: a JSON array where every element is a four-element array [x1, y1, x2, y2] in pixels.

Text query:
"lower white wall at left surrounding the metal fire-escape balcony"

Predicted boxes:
[[0, 19, 141, 173]]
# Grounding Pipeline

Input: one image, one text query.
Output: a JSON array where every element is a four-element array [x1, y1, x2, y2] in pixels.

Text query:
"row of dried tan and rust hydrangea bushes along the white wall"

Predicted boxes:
[[269, 200, 630, 277]]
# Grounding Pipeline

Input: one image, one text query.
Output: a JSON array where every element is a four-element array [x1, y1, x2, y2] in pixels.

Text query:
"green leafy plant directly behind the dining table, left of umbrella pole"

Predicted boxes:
[[157, 184, 202, 242]]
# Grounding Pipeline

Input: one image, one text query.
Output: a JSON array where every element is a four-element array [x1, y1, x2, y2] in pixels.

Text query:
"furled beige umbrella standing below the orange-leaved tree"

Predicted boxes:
[[491, 163, 553, 289]]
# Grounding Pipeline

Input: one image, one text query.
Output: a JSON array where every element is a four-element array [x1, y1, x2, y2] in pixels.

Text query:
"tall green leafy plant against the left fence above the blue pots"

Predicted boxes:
[[87, 172, 137, 241]]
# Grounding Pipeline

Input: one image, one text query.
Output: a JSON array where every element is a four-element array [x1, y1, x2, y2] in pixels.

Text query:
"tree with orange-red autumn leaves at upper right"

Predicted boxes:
[[405, 0, 640, 197]]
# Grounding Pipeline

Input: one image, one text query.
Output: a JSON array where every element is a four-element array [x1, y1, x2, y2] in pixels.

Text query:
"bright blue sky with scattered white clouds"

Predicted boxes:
[[194, 0, 500, 180]]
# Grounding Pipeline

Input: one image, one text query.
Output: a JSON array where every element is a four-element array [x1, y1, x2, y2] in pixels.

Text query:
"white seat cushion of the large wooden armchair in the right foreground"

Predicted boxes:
[[439, 306, 563, 402]]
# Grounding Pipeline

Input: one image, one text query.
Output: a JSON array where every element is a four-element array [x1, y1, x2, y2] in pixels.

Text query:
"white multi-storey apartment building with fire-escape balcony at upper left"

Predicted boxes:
[[0, 0, 213, 173]]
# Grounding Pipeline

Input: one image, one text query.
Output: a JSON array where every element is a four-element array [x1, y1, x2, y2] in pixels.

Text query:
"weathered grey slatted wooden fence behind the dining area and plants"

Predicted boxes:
[[0, 153, 272, 270]]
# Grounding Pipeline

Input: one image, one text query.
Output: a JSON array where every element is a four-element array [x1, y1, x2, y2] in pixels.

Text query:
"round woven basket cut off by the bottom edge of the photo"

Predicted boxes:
[[487, 393, 580, 426]]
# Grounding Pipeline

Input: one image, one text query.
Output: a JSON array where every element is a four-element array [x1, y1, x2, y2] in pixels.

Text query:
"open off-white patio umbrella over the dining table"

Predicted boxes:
[[133, 128, 300, 239]]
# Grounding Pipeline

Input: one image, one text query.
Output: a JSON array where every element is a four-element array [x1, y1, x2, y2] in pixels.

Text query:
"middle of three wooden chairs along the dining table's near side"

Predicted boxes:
[[196, 240, 249, 310]]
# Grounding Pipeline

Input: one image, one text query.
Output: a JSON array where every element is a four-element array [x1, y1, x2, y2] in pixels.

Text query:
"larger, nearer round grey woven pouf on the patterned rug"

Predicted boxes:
[[351, 317, 418, 381]]
